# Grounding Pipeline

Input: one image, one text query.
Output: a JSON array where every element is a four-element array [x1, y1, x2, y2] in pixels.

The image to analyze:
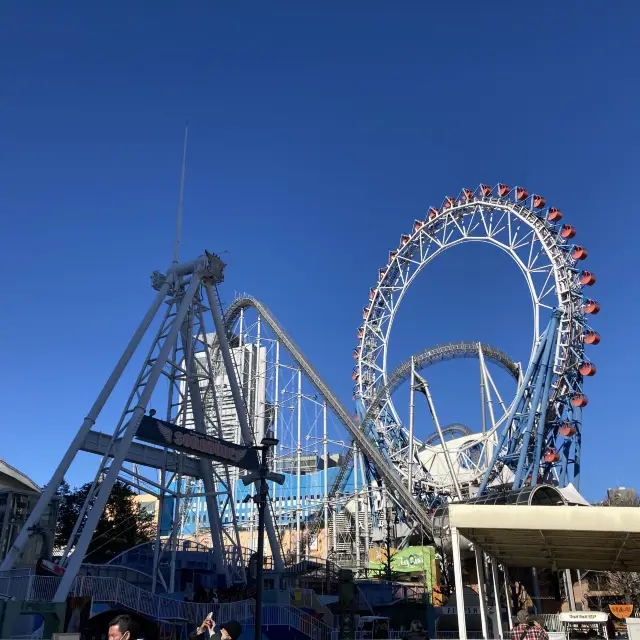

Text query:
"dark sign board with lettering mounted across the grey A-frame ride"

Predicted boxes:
[[136, 416, 258, 471]]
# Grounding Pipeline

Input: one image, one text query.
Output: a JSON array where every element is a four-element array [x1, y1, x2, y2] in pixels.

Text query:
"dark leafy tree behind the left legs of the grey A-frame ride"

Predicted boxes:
[[55, 482, 155, 564]]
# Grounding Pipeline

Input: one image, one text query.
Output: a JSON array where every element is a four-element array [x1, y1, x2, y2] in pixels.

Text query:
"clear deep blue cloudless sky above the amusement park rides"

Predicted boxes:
[[0, 0, 640, 499]]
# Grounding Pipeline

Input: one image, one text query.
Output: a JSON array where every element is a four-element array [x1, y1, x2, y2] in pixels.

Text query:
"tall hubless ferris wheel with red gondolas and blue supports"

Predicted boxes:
[[352, 184, 600, 498]]
